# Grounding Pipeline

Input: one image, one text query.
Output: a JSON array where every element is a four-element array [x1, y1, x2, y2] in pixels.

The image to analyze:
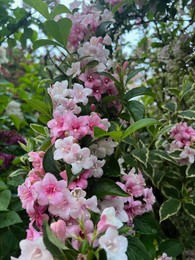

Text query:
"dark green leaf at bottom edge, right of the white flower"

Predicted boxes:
[[126, 236, 150, 260]]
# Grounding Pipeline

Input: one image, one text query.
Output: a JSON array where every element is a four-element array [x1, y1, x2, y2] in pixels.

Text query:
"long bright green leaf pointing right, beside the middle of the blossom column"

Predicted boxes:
[[122, 118, 159, 140]]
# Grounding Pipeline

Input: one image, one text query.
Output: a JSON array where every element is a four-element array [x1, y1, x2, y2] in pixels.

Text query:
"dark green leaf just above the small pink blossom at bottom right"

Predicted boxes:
[[158, 239, 183, 257]]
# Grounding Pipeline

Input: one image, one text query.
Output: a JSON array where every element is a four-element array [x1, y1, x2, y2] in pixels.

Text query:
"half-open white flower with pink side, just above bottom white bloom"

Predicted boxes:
[[97, 207, 123, 233]]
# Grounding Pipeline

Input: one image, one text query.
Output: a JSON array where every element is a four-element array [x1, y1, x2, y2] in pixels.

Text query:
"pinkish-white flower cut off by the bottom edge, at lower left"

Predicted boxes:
[[11, 237, 54, 260]]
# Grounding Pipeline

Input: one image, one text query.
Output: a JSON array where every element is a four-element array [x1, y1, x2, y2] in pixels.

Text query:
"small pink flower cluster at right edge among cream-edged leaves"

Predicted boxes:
[[169, 122, 195, 165]]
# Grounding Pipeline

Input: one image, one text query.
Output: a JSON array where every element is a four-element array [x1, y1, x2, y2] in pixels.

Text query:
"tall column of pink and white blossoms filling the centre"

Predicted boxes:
[[14, 1, 155, 260]]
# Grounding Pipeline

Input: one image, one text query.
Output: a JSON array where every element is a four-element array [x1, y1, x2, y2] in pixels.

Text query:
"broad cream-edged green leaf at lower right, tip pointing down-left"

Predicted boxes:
[[159, 199, 181, 222]]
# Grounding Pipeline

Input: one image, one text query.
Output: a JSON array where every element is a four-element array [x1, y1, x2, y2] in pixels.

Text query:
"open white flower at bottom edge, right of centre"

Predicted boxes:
[[99, 227, 128, 260]]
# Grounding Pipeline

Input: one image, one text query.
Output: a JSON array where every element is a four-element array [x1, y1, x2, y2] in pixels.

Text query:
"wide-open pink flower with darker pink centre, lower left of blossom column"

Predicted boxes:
[[33, 173, 67, 206]]
